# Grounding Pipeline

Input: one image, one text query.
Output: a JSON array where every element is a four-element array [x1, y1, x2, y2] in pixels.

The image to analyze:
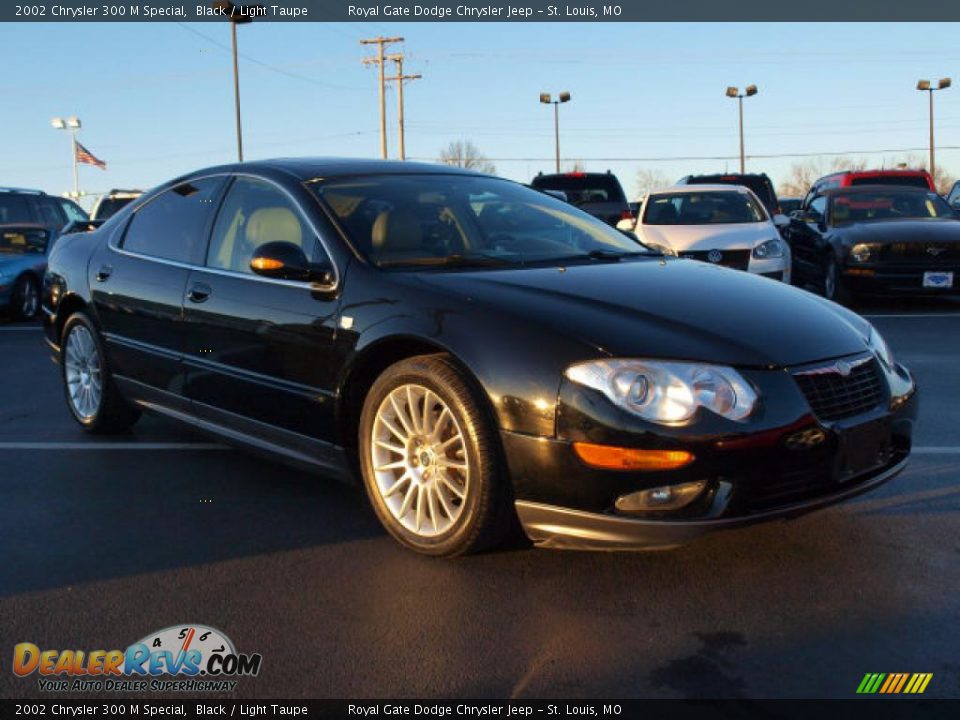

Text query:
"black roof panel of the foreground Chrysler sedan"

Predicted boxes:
[[178, 157, 487, 182]]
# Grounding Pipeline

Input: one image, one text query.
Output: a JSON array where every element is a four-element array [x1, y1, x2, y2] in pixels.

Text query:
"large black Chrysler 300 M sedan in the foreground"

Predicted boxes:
[[44, 159, 916, 555]]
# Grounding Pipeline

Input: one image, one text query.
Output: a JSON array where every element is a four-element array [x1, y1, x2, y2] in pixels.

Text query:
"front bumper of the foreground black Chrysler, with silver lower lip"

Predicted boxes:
[[501, 358, 918, 550]]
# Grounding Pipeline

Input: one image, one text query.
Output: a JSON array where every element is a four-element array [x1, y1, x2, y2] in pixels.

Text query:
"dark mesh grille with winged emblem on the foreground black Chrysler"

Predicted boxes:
[[793, 357, 883, 421]]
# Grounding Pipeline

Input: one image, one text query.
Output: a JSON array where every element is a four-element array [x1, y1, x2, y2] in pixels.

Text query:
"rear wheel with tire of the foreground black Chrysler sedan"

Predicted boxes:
[[60, 312, 140, 435]]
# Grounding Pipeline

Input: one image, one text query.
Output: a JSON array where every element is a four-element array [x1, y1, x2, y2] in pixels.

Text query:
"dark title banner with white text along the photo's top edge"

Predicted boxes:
[[0, 0, 960, 22]]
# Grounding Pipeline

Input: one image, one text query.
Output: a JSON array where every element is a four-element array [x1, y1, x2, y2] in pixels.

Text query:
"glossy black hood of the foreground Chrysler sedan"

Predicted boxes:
[[408, 258, 870, 367]]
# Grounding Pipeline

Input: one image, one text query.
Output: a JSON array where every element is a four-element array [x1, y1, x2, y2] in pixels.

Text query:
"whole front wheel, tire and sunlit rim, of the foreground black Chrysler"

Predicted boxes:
[[359, 355, 513, 556]]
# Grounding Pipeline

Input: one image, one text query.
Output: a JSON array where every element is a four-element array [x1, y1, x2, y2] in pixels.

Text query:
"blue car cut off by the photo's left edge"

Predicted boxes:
[[0, 224, 53, 320]]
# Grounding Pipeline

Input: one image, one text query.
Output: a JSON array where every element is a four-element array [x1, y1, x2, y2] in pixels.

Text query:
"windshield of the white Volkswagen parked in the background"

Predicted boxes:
[[643, 190, 767, 225]]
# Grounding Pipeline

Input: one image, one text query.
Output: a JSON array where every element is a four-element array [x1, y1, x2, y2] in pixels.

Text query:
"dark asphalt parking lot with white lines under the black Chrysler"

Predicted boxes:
[[0, 301, 960, 698]]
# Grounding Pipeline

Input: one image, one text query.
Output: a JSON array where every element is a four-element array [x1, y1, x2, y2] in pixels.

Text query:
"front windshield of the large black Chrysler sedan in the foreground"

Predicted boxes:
[[308, 174, 649, 267]]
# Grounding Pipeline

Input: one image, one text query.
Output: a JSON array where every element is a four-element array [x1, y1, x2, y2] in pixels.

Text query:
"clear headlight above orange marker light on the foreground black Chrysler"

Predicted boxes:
[[566, 360, 757, 425]]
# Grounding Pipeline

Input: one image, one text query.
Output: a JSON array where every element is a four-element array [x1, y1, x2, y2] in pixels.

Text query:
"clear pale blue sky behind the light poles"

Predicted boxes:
[[0, 21, 960, 205]]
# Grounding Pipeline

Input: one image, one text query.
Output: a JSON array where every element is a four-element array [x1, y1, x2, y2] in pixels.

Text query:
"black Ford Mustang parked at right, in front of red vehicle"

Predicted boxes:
[[783, 185, 960, 303]]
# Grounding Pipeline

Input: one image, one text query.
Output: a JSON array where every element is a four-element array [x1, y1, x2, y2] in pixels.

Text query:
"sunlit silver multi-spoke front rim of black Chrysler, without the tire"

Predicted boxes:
[[370, 384, 470, 537]]
